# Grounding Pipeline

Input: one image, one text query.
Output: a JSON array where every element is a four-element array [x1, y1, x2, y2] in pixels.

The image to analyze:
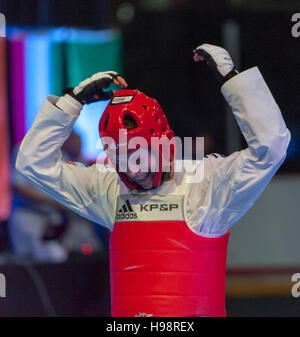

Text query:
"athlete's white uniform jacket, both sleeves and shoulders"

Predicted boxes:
[[16, 67, 290, 237]]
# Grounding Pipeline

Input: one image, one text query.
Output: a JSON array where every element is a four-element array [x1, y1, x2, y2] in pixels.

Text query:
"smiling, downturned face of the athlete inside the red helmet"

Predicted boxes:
[[118, 149, 156, 190]]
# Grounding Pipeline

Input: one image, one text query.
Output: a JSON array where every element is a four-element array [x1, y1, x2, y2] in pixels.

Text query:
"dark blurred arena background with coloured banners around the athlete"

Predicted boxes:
[[0, 0, 300, 316]]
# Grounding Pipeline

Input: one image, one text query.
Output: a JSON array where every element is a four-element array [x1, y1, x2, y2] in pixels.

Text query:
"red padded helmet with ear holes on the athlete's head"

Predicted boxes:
[[99, 90, 175, 189]]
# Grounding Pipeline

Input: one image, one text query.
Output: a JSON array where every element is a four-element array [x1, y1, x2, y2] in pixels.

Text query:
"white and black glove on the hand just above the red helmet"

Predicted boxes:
[[63, 71, 119, 104]]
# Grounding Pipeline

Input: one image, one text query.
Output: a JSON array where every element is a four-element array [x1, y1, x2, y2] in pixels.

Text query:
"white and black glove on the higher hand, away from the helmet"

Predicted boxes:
[[194, 43, 238, 83]]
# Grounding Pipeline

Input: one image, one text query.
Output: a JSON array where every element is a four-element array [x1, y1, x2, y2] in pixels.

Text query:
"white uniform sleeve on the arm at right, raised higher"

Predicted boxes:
[[188, 68, 290, 235]]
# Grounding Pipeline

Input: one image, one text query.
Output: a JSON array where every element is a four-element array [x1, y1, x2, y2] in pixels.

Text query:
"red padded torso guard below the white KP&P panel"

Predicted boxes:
[[110, 221, 229, 317]]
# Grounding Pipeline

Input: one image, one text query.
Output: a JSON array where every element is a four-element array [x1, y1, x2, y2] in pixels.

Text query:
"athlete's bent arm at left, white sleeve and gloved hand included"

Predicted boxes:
[[16, 72, 126, 228]]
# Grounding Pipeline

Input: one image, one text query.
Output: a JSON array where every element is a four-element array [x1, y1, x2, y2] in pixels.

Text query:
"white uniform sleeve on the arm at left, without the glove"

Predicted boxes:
[[16, 96, 118, 229]]
